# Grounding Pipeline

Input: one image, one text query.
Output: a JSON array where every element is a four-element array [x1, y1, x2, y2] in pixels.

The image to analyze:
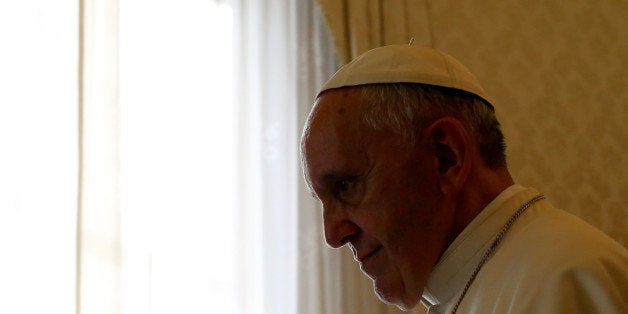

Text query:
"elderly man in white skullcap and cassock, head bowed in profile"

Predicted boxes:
[[302, 45, 628, 313]]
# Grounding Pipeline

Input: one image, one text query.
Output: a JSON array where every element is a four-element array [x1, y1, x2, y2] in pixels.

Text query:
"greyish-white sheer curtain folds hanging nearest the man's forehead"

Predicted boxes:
[[233, 0, 297, 313]]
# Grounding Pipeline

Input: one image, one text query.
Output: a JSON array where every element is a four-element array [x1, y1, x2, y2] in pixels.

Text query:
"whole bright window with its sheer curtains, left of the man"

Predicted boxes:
[[0, 0, 300, 314]]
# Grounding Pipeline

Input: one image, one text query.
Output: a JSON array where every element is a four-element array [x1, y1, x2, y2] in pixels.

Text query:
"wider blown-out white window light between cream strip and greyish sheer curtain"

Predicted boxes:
[[120, 0, 236, 314]]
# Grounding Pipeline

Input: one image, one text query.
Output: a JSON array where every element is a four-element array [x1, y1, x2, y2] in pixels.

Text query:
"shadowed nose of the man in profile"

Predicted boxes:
[[323, 205, 360, 248]]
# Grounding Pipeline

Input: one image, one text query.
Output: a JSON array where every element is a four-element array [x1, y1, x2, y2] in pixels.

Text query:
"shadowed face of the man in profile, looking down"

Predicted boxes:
[[303, 88, 454, 309]]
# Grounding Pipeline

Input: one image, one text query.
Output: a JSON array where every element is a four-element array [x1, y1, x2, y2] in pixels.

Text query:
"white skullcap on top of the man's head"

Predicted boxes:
[[318, 45, 490, 103]]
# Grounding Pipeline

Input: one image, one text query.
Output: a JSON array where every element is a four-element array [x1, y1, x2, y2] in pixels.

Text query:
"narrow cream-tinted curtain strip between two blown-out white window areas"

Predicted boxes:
[[76, 0, 121, 313]]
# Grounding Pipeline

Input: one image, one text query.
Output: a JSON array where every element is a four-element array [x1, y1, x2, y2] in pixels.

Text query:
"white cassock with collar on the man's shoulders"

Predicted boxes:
[[423, 185, 628, 314]]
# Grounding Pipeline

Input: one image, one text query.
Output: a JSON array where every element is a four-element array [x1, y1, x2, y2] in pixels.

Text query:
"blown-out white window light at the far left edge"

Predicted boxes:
[[0, 0, 78, 314]]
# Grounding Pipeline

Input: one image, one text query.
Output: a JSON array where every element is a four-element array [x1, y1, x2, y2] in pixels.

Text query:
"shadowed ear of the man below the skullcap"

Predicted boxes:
[[424, 117, 473, 195]]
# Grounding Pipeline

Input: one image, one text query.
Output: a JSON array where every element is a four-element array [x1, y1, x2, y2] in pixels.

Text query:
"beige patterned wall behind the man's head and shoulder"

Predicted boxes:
[[420, 0, 628, 246]]
